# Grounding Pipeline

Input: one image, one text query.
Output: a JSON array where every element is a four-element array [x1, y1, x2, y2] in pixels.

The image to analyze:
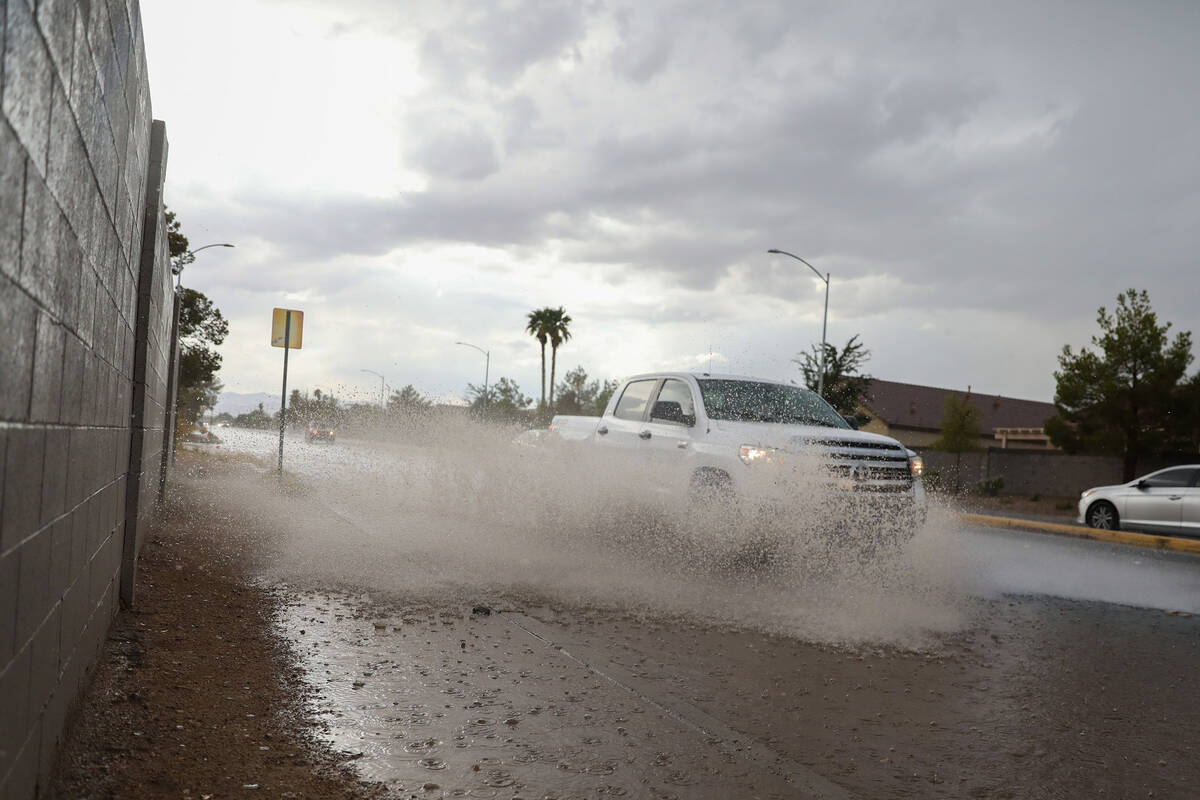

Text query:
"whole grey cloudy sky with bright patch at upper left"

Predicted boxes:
[[142, 0, 1200, 399]]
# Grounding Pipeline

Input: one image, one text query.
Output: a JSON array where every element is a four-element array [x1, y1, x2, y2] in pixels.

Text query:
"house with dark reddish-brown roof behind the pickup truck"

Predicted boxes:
[[860, 379, 1055, 450]]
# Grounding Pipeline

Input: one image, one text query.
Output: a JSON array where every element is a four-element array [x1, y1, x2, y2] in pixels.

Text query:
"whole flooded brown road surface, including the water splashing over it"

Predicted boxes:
[[214, 429, 1200, 799]]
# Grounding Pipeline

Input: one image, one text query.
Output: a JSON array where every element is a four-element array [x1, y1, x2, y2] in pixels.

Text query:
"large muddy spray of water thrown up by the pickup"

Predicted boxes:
[[204, 420, 964, 649]]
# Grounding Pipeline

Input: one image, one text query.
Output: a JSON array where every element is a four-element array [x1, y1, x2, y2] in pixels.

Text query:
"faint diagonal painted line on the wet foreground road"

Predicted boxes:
[[499, 612, 856, 800]]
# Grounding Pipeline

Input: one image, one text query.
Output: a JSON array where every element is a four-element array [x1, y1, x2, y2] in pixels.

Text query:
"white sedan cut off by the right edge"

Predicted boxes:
[[1078, 464, 1200, 536]]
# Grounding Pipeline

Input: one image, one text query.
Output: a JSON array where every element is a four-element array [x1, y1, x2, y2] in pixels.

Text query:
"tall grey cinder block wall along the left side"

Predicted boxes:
[[0, 0, 173, 798]]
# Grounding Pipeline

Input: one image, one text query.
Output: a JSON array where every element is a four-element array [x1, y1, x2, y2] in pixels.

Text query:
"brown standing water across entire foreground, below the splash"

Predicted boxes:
[[277, 594, 1200, 800]]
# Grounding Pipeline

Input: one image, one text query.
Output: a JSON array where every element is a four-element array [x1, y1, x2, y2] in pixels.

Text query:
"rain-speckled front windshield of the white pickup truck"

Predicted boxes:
[[697, 379, 850, 428]]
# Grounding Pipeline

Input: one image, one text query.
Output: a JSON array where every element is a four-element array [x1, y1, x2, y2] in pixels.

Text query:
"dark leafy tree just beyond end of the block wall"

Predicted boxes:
[[175, 289, 229, 422]]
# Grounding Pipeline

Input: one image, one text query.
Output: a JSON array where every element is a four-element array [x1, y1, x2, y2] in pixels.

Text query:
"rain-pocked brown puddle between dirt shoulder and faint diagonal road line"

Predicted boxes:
[[277, 594, 788, 800]]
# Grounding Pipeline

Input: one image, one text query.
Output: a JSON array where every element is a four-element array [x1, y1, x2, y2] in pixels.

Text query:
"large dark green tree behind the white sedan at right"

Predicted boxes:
[[1046, 289, 1196, 481]]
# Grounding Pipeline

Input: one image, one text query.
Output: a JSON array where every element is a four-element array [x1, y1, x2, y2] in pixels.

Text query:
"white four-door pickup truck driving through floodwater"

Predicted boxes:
[[550, 372, 925, 533]]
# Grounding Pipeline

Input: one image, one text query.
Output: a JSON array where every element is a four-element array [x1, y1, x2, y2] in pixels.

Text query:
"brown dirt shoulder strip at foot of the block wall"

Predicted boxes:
[[48, 453, 382, 800]]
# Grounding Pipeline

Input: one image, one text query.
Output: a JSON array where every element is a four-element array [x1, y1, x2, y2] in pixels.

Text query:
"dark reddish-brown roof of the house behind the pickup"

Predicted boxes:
[[863, 378, 1055, 435]]
